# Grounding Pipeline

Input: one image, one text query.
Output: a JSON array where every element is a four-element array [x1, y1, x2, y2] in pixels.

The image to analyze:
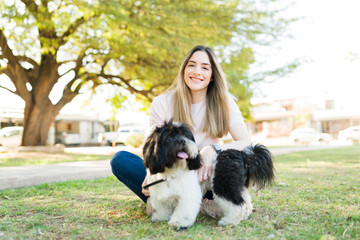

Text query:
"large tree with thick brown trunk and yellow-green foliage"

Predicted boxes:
[[0, 0, 290, 146]]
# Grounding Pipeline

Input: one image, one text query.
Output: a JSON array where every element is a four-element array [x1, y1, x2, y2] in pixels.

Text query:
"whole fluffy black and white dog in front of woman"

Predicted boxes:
[[143, 121, 274, 229]]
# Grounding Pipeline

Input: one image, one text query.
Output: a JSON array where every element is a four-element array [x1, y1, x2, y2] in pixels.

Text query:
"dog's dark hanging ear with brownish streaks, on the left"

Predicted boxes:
[[143, 130, 165, 174]]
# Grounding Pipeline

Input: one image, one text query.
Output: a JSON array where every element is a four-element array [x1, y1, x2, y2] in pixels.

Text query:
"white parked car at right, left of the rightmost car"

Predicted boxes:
[[290, 128, 332, 143]]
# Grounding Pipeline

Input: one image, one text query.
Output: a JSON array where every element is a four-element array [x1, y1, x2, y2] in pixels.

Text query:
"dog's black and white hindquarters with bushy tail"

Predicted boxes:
[[201, 144, 274, 225]]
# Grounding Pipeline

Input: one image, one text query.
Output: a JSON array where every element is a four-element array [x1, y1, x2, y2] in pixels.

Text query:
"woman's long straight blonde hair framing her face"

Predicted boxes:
[[168, 46, 230, 138]]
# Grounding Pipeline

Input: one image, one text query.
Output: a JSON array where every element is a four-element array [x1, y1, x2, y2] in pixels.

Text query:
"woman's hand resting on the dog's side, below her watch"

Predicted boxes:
[[196, 146, 217, 182]]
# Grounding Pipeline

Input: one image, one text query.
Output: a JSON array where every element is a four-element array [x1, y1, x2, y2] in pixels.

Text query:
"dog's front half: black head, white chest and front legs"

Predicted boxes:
[[143, 121, 202, 230]]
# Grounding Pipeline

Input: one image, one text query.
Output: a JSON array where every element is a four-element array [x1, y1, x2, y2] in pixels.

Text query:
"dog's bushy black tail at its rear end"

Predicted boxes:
[[244, 144, 275, 189]]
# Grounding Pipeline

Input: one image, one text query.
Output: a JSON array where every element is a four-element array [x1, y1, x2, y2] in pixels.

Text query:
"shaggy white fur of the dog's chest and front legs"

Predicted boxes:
[[148, 160, 202, 228]]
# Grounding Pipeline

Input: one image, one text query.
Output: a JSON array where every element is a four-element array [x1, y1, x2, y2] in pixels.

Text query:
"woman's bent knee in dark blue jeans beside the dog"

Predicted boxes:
[[110, 151, 148, 203]]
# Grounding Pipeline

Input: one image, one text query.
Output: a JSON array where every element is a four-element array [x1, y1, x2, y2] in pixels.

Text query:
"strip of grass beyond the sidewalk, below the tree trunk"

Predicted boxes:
[[0, 152, 112, 167]]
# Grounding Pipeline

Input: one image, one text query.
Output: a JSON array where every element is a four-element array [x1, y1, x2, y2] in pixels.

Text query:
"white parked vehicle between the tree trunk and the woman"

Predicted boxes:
[[98, 127, 146, 146]]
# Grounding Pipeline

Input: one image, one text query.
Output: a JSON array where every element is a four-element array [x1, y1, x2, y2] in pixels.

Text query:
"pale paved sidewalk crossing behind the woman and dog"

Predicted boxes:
[[0, 145, 341, 190]]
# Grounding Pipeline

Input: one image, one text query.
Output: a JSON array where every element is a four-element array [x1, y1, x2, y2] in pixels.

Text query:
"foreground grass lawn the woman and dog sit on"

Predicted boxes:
[[0, 146, 360, 240]]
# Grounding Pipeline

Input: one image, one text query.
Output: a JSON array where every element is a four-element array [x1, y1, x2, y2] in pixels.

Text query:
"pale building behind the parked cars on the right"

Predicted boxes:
[[251, 93, 360, 137]]
